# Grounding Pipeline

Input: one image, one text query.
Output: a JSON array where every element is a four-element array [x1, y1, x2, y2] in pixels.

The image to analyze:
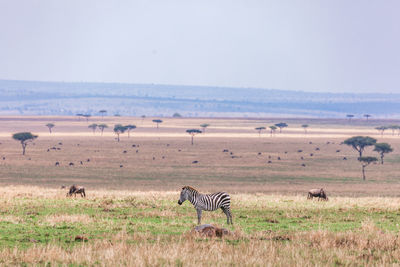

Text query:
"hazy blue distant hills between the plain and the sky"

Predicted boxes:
[[0, 80, 400, 118]]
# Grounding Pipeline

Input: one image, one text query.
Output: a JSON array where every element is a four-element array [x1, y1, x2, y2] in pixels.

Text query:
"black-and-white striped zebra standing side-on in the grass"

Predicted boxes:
[[178, 186, 233, 224]]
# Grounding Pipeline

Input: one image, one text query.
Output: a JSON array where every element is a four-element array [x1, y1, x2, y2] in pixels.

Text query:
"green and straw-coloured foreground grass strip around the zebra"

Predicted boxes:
[[0, 186, 400, 266]]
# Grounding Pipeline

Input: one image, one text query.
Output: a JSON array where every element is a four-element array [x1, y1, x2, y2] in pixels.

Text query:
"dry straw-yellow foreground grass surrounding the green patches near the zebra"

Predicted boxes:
[[0, 186, 400, 266]]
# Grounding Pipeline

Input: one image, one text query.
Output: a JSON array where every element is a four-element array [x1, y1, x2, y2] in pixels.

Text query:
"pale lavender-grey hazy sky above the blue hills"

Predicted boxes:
[[0, 0, 400, 93]]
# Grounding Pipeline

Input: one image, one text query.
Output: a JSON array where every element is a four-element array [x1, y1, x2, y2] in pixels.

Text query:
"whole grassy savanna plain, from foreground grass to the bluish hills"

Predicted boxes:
[[0, 116, 400, 266]]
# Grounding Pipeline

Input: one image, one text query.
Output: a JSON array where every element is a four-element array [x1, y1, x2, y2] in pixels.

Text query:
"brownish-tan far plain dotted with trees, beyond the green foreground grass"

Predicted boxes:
[[0, 117, 400, 196]]
